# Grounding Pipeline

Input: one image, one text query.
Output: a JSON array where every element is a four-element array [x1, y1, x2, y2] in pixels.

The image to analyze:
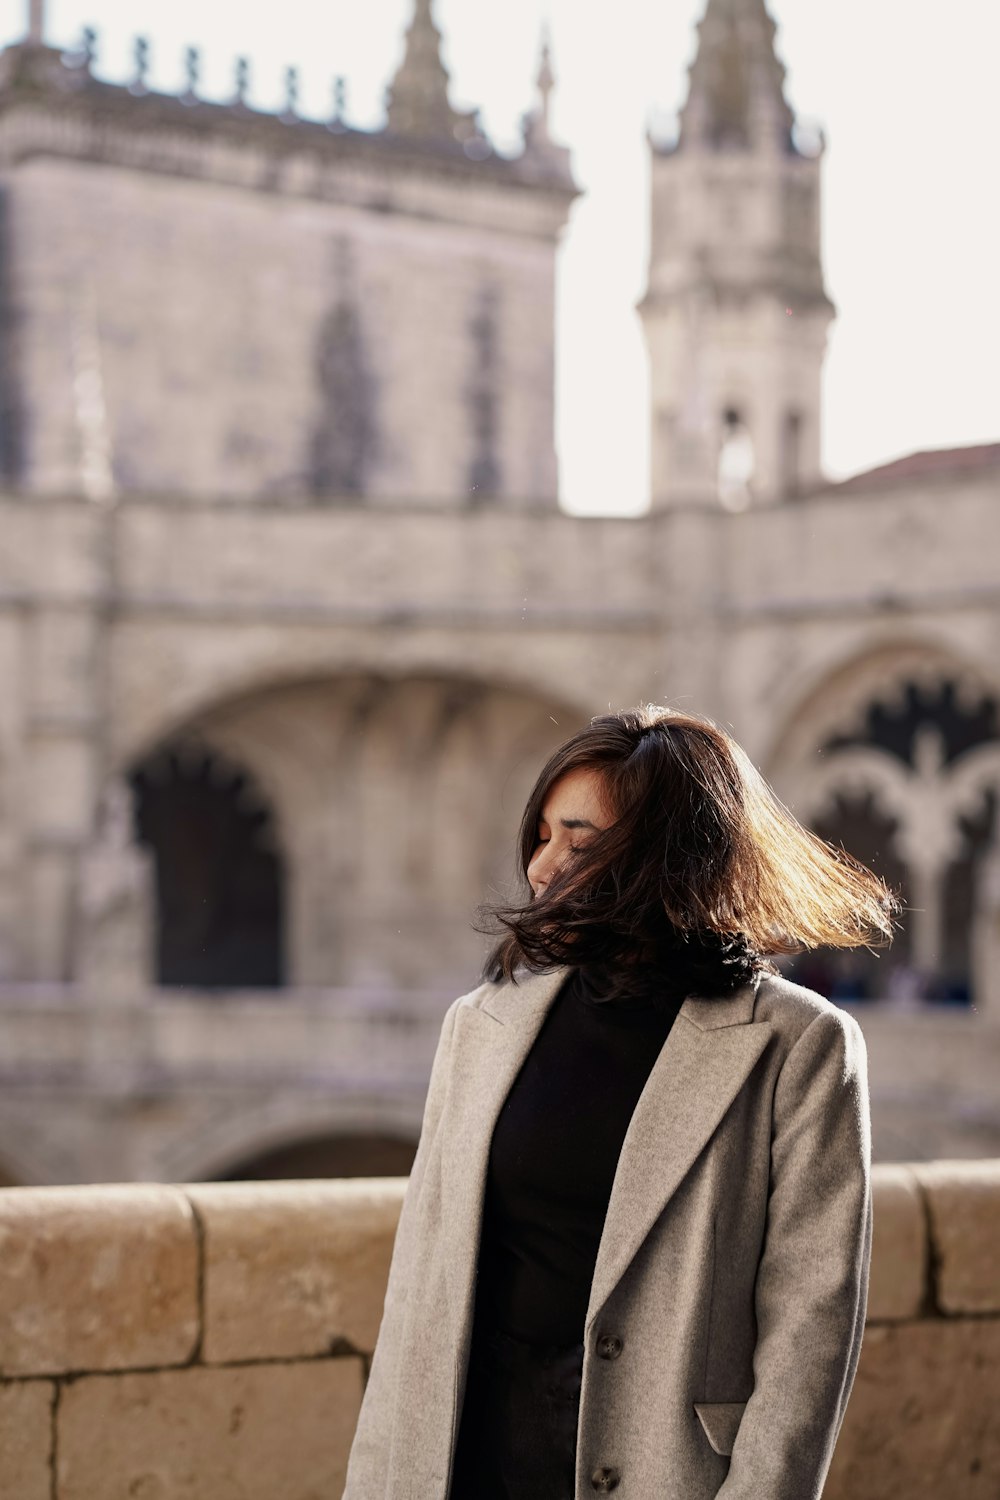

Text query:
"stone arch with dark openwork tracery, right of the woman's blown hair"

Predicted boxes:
[[772, 642, 1000, 1001]]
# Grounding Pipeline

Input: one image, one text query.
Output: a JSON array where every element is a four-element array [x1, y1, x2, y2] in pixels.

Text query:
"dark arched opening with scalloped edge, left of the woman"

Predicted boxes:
[[129, 741, 285, 989]]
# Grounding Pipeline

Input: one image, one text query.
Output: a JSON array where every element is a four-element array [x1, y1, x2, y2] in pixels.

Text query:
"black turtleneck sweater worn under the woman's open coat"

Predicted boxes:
[[475, 969, 684, 1346]]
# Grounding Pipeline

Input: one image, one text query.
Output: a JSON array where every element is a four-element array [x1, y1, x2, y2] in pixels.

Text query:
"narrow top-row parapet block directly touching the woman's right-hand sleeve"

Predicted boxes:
[[868, 1166, 928, 1322]]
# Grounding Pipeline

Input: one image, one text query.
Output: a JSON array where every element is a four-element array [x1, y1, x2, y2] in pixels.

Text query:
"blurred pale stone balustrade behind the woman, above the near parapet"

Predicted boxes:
[[0, 980, 1000, 1185]]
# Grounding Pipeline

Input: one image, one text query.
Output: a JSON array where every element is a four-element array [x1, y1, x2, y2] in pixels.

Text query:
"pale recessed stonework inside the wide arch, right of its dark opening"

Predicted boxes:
[[124, 671, 585, 993]]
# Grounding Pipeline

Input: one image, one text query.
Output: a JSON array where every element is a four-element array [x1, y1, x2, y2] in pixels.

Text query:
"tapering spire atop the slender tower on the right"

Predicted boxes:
[[679, 0, 795, 150]]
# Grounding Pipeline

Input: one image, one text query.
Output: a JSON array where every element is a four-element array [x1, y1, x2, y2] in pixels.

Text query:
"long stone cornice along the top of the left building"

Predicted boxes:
[[0, 48, 577, 237]]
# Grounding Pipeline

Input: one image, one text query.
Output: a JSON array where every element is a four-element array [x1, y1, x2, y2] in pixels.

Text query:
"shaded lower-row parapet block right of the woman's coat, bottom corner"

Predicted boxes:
[[823, 1319, 1000, 1500]]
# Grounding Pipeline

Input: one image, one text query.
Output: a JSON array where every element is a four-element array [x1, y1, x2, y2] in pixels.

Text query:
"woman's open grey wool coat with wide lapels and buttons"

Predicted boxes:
[[345, 971, 871, 1500]]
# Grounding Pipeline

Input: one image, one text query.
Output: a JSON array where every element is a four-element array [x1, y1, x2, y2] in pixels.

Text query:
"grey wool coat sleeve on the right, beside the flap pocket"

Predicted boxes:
[[718, 1010, 871, 1500]]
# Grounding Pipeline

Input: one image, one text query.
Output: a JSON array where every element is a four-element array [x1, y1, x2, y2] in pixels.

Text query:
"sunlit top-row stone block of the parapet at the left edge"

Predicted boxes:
[[0, 1187, 198, 1376]]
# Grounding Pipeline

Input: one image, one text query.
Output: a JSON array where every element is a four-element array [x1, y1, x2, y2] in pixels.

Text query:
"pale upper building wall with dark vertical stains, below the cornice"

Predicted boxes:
[[0, 149, 556, 504]]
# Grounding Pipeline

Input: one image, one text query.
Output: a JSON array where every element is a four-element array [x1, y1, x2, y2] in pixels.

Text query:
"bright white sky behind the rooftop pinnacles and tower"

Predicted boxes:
[[0, 0, 1000, 512]]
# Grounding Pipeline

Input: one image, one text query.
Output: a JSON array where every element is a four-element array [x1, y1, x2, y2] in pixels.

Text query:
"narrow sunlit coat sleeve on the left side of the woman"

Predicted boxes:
[[343, 1001, 462, 1500]]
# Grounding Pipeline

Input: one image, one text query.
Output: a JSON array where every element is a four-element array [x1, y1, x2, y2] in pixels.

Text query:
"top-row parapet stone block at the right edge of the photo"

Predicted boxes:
[[913, 1161, 1000, 1313]]
